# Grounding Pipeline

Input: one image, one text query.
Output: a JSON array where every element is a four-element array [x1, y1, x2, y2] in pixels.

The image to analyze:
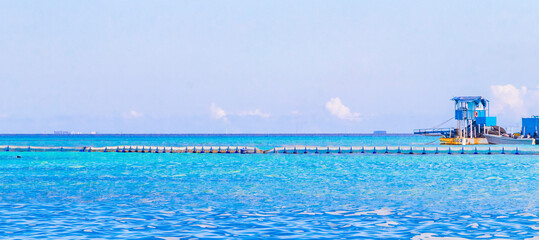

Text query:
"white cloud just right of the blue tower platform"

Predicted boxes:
[[490, 84, 528, 116]]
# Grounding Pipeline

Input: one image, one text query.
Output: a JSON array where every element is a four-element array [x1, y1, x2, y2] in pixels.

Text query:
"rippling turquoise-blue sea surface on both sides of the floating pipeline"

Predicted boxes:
[[0, 135, 539, 240]]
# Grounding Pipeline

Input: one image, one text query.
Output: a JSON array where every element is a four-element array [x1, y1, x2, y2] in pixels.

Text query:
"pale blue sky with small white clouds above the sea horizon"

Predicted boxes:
[[0, 1, 539, 133]]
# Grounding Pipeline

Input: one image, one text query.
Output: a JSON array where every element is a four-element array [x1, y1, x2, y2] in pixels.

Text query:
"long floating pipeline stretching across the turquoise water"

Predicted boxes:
[[0, 145, 539, 155]]
